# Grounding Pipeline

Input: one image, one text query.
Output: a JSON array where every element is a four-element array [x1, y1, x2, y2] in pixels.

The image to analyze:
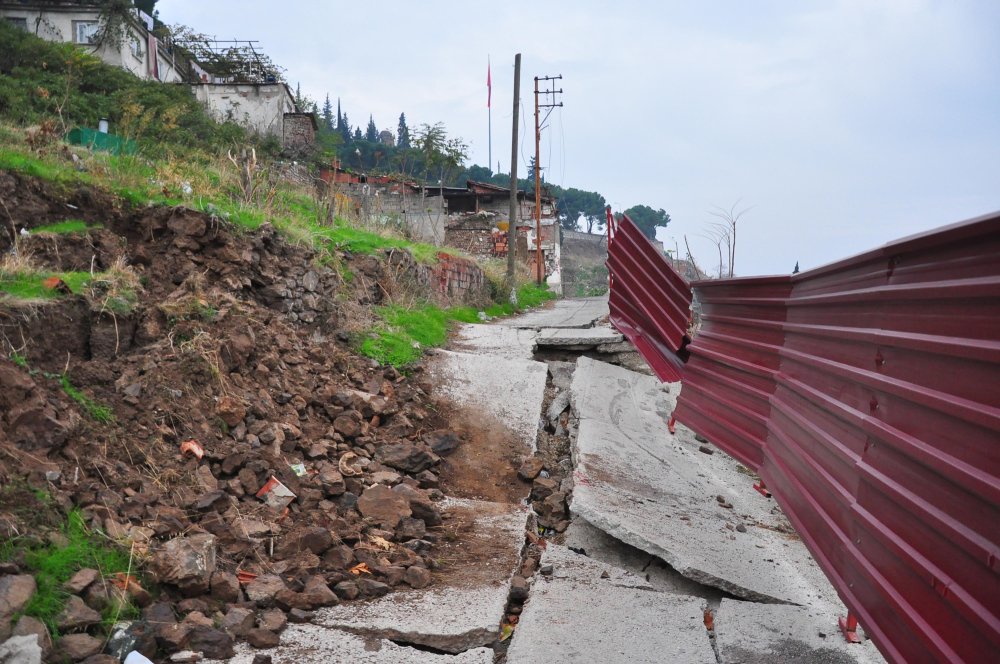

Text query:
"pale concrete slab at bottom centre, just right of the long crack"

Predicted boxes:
[[507, 544, 715, 664]]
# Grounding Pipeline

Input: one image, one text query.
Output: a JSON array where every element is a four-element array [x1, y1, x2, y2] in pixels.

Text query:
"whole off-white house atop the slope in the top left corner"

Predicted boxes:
[[0, 0, 191, 83]]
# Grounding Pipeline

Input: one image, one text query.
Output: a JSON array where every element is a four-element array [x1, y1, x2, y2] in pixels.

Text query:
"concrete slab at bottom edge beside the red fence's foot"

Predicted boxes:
[[715, 599, 885, 664]]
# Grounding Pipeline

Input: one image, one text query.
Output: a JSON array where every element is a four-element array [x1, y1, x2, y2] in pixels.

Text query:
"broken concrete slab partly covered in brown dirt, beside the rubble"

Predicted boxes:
[[314, 498, 528, 653]]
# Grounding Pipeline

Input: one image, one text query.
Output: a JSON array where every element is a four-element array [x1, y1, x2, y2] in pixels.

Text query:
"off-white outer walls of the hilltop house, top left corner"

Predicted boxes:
[[0, 2, 190, 83]]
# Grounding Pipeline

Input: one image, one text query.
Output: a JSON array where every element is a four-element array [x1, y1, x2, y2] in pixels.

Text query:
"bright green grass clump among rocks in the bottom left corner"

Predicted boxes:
[[0, 508, 138, 634]]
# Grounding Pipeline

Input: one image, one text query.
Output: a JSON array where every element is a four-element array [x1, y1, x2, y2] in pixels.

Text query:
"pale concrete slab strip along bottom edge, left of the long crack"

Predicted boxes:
[[203, 624, 493, 664]]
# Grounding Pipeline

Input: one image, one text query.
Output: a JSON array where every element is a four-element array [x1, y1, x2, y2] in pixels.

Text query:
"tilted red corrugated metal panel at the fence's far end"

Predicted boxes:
[[608, 213, 691, 382]]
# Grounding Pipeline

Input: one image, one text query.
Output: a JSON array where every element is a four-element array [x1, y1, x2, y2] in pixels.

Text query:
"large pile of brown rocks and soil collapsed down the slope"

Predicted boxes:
[[0, 172, 490, 664]]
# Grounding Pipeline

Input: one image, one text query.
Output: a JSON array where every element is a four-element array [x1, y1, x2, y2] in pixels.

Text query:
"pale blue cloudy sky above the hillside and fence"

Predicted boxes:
[[157, 0, 1000, 276]]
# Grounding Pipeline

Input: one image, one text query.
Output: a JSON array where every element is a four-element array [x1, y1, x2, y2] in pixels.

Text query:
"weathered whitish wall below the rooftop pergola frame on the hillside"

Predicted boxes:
[[192, 83, 295, 139]]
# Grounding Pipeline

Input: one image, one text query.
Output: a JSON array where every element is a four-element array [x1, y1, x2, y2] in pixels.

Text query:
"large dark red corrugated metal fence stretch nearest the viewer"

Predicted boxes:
[[672, 215, 1000, 662]]
